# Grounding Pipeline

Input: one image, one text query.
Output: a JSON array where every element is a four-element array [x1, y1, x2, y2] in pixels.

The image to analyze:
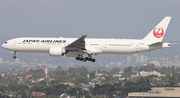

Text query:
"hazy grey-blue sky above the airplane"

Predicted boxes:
[[0, 0, 180, 41]]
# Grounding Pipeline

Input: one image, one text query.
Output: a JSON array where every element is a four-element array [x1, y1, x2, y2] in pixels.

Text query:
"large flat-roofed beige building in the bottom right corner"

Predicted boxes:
[[128, 87, 180, 98]]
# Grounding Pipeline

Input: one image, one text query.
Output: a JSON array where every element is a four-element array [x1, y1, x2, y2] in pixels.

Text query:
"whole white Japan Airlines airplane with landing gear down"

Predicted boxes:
[[2, 16, 171, 62]]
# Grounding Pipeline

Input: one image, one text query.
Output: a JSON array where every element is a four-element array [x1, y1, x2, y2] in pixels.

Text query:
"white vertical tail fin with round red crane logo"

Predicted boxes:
[[143, 16, 171, 42]]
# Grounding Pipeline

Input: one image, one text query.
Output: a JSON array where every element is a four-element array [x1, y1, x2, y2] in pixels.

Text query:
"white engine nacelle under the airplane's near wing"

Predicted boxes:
[[49, 47, 66, 56]]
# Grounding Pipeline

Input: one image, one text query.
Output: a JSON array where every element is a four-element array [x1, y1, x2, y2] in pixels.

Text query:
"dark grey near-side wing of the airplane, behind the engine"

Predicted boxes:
[[66, 35, 87, 51]]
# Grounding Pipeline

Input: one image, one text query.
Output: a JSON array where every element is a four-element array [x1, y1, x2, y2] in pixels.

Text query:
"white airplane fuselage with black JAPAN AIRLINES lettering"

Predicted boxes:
[[2, 37, 163, 54]]
